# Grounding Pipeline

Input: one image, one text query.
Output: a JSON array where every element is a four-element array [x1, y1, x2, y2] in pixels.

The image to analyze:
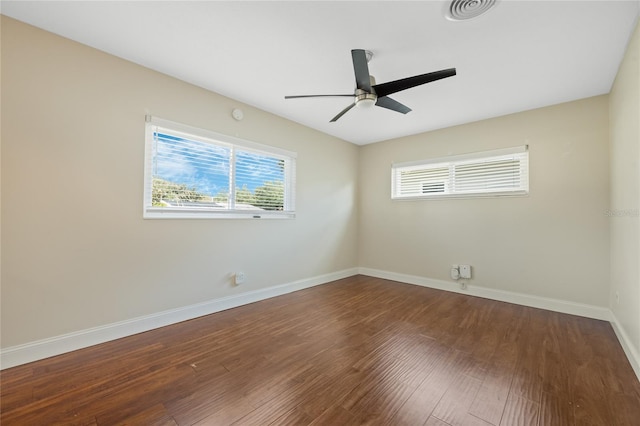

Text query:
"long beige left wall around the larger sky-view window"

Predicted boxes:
[[1, 16, 358, 348]]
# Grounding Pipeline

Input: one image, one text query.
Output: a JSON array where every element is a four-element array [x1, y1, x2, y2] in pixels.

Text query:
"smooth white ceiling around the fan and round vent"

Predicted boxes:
[[1, 0, 640, 144]]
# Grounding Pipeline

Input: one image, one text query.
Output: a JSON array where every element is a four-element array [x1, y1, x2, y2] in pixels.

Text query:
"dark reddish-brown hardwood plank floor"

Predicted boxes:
[[0, 276, 640, 426]]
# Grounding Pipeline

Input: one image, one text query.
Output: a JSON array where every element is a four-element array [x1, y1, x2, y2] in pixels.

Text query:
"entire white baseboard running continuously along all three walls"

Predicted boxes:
[[0, 268, 640, 380]]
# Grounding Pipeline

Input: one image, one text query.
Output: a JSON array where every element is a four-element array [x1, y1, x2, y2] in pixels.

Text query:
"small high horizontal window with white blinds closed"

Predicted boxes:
[[391, 146, 529, 199]]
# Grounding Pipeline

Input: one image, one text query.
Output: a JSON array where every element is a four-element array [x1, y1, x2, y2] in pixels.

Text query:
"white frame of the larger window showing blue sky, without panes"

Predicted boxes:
[[143, 115, 297, 219]]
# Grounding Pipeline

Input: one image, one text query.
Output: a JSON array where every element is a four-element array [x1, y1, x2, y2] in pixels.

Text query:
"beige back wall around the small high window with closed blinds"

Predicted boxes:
[[359, 96, 609, 306]]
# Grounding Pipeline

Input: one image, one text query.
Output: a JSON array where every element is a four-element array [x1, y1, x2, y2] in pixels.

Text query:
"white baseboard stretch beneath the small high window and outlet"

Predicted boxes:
[[358, 268, 612, 321]]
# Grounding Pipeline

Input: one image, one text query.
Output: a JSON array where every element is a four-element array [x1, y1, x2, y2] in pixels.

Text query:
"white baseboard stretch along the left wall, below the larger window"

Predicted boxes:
[[0, 268, 358, 369]]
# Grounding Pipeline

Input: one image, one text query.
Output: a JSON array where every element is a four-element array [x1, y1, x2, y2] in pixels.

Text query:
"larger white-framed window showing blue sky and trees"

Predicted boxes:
[[144, 117, 296, 218]]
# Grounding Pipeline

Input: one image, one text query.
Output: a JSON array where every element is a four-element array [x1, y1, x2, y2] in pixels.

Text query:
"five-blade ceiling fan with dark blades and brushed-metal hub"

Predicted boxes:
[[284, 49, 456, 122]]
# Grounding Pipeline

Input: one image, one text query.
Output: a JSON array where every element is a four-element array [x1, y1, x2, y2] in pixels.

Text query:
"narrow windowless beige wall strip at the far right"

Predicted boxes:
[[609, 19, 640, 361]]
